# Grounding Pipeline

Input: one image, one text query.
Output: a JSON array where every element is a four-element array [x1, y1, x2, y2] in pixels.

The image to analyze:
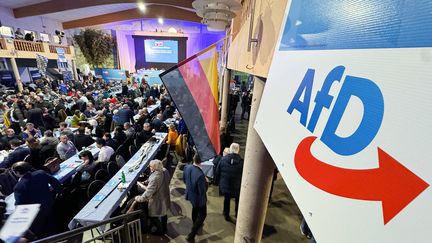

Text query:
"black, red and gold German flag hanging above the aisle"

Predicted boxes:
[[159, 44, 220, 161]]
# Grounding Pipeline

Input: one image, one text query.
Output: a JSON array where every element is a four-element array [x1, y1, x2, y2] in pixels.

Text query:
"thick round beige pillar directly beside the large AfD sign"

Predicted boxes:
[[234, 77, 275, 243]]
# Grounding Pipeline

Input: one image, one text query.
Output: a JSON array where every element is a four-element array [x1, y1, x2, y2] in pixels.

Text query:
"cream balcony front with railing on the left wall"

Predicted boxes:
[[0, 38, 75, 60]]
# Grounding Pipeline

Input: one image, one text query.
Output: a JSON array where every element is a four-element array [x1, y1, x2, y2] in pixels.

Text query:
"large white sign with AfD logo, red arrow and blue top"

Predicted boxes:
[[255, 0, 432, 243]]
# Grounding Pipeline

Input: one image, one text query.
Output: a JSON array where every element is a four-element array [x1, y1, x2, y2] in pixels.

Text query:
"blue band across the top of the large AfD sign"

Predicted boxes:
[[280, 0, 432, 51]]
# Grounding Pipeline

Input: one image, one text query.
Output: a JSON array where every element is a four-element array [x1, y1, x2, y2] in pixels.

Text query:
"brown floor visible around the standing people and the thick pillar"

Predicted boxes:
[[144, 108, 307, 243]]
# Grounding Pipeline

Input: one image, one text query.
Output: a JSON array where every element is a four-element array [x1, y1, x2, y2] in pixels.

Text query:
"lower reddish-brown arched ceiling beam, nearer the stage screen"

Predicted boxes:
[[63, 5, 201, 29]]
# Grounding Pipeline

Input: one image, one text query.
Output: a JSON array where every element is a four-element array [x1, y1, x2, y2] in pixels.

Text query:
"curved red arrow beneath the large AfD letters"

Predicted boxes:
[[295, 136, 429, 224]]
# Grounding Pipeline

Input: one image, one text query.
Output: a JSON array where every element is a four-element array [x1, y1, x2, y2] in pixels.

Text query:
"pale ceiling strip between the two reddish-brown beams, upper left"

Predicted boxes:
[[41, 3, 137, 22]]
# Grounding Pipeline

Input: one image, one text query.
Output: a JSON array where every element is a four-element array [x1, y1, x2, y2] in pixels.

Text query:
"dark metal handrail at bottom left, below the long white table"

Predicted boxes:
[[33, 210, 142, 243]]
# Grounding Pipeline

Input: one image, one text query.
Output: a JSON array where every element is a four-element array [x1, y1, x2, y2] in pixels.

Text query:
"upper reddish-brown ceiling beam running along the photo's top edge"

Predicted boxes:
[[13, 0, 192, 18]]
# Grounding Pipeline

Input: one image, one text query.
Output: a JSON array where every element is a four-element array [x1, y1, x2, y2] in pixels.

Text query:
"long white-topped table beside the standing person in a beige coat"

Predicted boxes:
[[69, 133, 167, 229]]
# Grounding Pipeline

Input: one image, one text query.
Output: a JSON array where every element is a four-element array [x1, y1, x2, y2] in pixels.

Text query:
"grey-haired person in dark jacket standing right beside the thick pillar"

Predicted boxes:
[[215, 143, 243, 222]]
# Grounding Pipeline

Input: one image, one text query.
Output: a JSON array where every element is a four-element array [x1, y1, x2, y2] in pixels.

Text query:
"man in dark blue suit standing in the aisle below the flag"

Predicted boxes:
[[183, 154, 208, 242]]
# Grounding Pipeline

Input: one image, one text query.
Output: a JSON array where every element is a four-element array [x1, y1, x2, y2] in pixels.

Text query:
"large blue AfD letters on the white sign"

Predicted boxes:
[[288, 66, 384, 156]]
